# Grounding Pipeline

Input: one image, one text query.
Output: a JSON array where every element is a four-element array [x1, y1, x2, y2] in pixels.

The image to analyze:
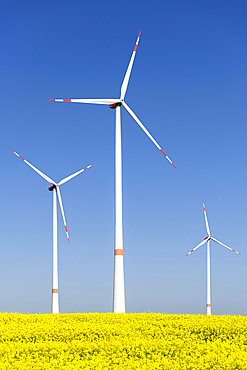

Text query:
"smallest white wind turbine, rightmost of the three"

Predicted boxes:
[[186, 202, 240, 315]]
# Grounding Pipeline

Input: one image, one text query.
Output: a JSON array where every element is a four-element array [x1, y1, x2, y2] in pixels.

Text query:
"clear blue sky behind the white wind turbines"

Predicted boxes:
[[0, 0, 247, 314]]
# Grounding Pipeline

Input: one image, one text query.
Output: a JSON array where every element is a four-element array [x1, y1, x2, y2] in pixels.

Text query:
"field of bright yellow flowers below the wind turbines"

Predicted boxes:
[[0, 313, 247, 370]]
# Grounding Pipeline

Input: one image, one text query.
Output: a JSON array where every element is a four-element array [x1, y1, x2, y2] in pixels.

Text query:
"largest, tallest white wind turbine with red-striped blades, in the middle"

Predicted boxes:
[[48, 32, 177, 313]]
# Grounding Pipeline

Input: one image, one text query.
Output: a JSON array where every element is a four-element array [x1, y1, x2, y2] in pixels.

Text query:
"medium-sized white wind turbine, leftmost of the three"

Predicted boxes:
[[10, 149, 93, 313]]
